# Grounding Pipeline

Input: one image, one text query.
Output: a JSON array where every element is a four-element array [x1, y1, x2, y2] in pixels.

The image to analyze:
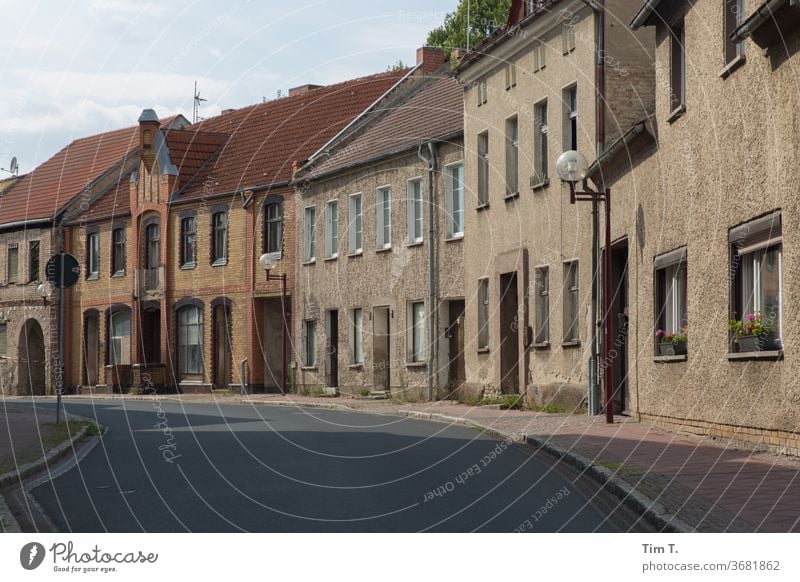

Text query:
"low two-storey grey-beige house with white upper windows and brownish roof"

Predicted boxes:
[[295, 48, 465, 400]]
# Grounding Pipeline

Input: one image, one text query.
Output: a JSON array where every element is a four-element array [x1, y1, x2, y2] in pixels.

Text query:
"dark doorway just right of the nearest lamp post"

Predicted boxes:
[[611, 240, 630, 414]]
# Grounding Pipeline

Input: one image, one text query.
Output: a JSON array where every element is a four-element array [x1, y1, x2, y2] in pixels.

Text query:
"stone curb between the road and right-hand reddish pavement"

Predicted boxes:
[[243, 400, 695, 533]]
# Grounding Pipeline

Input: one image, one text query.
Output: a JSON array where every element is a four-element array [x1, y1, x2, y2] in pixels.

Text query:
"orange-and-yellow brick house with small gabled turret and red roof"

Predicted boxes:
[[68, 71, 405, 392]]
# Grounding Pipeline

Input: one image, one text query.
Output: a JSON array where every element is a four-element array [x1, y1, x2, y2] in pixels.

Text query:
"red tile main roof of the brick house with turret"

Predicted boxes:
[[176, 70, 408, 199]]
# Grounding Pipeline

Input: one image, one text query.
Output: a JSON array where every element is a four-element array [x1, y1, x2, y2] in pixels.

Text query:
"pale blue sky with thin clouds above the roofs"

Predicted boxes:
[[0, 0, 457, 179]]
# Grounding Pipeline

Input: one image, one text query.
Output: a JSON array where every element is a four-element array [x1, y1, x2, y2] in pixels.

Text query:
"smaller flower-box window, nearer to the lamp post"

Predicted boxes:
[[653, 247, 688, 352]]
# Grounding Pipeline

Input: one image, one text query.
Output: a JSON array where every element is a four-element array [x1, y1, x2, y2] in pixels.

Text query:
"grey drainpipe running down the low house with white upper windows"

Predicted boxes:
[[417, 141, 439, 402]]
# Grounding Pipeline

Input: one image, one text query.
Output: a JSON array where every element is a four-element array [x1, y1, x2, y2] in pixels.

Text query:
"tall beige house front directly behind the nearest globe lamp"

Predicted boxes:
[[457, 0, 655, 411]]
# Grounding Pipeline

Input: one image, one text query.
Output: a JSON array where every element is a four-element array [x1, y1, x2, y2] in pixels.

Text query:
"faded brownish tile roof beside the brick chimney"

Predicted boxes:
[[302, 76, 464, 180]]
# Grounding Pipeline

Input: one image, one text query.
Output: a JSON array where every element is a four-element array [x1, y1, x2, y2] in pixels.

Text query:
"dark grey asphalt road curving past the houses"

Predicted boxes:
[[15, 400, 646, 532]]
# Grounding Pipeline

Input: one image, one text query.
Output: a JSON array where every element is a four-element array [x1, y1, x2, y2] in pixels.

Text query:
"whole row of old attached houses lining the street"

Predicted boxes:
[[0, 0, 800, 452]]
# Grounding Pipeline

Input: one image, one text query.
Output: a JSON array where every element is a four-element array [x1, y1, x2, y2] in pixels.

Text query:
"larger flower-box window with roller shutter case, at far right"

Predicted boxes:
[[730, 212, 783, 346]]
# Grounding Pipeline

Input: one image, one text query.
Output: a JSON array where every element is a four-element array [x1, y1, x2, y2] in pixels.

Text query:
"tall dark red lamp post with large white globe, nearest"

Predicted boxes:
[[556, 150, 614, 424]]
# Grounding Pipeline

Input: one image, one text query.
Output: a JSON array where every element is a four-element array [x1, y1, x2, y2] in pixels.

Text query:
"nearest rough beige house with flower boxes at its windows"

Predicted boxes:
[[596, 0, 800, 454]]
